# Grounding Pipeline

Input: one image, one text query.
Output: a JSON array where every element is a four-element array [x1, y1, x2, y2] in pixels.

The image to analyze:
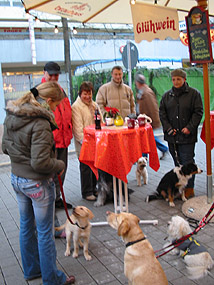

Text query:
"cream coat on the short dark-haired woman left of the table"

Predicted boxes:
[[71, 96, 102, 157]]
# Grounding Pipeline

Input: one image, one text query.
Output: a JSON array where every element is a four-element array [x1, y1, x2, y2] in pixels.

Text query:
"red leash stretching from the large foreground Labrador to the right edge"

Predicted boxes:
[[155, 202, 214, 258]]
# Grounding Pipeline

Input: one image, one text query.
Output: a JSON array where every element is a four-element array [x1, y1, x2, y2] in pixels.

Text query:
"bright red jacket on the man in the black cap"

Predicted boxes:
[[42, 77, 73, 148]]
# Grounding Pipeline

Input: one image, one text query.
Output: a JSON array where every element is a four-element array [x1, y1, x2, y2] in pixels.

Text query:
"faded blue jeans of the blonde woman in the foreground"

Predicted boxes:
[[11, 174, 66, 285]]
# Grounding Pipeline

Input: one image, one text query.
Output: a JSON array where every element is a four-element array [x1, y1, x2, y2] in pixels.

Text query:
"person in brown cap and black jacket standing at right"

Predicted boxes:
[[159, 69, 203, 198]]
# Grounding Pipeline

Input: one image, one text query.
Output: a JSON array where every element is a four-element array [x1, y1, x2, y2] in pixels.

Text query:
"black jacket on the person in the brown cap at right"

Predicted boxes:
[[159, 83, 203, 144]]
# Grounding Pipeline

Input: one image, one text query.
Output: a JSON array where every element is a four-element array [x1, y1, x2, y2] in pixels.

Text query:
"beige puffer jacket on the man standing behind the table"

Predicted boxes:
[[96, 79, 136, 119]]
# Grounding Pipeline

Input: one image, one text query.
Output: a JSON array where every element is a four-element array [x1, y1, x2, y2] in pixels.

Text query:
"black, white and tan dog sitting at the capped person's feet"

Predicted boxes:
[[146, 163, 203, 207]]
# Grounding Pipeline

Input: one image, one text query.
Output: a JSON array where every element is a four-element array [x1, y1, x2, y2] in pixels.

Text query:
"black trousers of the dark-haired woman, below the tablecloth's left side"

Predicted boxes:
[[80, 162, 97, 198]]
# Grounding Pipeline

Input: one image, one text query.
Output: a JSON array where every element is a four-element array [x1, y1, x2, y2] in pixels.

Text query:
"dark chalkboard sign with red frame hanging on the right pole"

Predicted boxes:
[[186, 7, 213, 63]]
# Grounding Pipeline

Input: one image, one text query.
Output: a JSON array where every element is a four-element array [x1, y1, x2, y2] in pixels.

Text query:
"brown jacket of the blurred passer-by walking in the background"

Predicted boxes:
[[137, 84, 161, 129]]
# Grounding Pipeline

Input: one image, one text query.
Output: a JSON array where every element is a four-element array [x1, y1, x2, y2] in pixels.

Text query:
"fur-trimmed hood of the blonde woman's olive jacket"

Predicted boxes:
[[5, 101, 54, 130]]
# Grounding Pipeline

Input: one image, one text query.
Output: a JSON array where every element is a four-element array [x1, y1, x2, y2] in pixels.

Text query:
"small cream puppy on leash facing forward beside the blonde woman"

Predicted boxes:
[[55, 206, 94, 260]]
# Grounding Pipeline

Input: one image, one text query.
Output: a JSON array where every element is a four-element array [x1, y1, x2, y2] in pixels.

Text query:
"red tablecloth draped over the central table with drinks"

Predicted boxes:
[[79, 124, 160, 183]]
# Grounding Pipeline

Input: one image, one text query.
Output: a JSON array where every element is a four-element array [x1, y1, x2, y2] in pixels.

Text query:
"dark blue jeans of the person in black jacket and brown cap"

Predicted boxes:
[[168, 143, 195, 188]]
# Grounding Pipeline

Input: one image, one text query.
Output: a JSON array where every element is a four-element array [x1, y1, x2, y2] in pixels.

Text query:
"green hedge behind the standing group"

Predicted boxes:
[[72, 65, 214, 120]]
